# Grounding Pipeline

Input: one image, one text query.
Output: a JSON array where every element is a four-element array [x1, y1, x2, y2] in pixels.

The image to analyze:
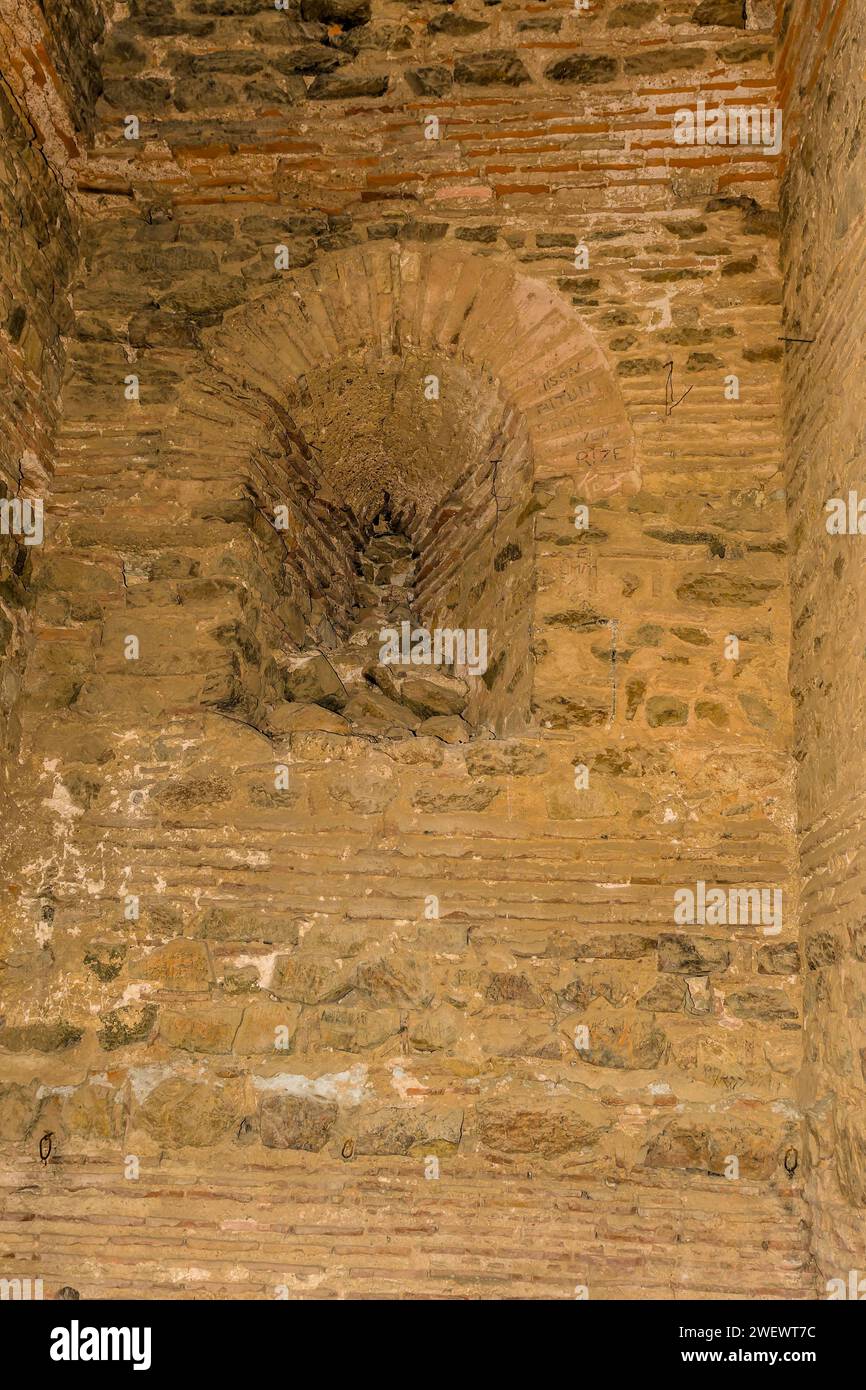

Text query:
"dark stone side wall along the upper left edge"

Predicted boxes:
[[0, 0, 96, 778]]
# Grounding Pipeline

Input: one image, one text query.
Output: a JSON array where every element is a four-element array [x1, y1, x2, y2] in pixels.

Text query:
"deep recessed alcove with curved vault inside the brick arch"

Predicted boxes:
[[261, 353, 534, 733]]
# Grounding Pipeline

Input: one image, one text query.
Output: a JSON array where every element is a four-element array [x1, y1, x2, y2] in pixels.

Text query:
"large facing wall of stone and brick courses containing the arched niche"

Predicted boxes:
[[0, 0, 839, 1297]]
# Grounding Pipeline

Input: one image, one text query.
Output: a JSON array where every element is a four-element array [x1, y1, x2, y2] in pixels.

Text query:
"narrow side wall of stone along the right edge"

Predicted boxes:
[[781, 4, 866, 1279]]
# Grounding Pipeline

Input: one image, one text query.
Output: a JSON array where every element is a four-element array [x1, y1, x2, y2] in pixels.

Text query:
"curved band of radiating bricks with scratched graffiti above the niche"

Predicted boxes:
[[206, 243, 639, 502]]
